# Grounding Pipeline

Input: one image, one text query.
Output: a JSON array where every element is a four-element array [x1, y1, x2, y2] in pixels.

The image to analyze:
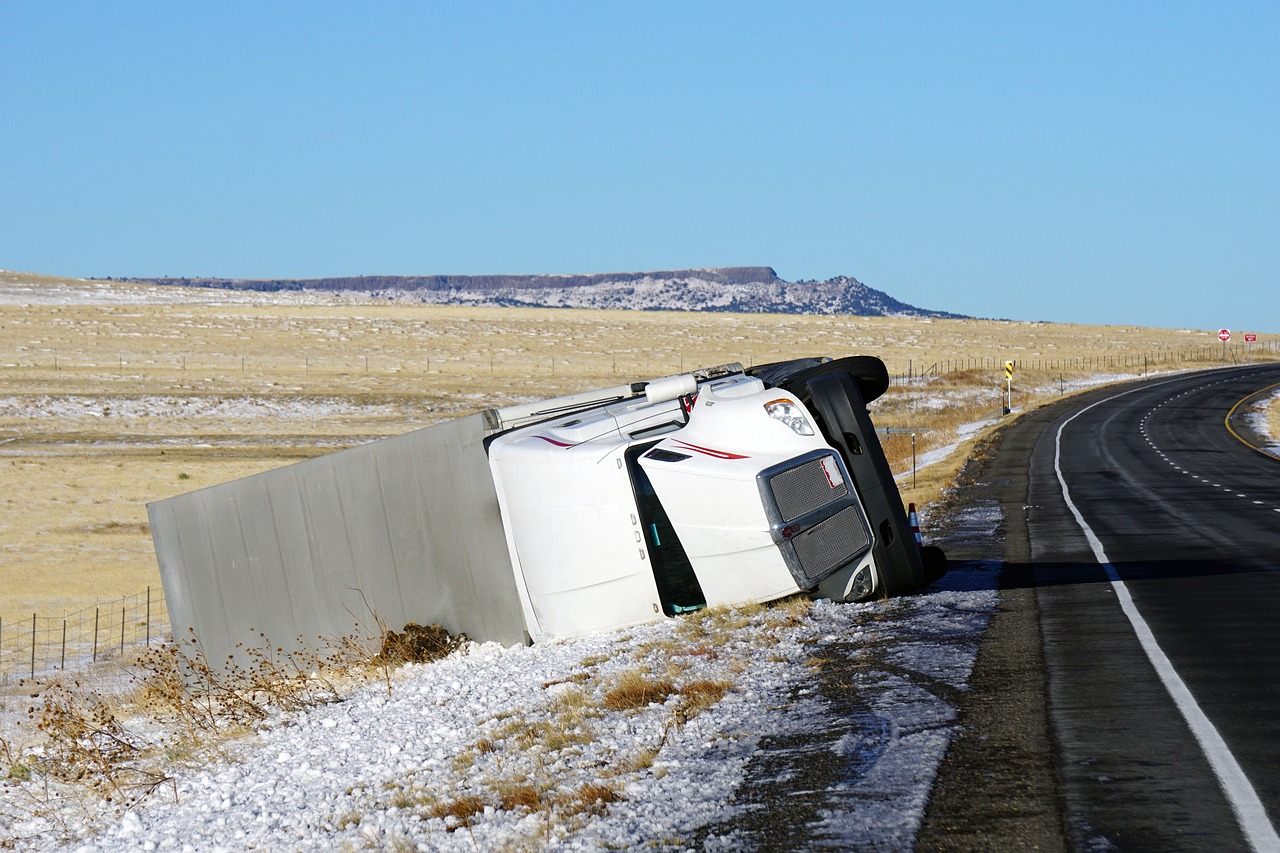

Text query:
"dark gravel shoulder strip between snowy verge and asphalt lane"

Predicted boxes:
[[916, 410, 1068, 852]]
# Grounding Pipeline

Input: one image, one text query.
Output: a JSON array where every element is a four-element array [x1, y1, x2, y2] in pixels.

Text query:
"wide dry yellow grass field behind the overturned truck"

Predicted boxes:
[[0, 272, 1276, 624]]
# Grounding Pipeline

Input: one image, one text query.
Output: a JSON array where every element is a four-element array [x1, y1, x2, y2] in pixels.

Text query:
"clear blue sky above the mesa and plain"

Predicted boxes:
[[0, 0, 1280, 332]]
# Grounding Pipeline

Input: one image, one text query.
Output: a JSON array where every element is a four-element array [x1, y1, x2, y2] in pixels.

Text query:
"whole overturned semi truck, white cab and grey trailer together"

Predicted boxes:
[[147, 356, 946, 663]]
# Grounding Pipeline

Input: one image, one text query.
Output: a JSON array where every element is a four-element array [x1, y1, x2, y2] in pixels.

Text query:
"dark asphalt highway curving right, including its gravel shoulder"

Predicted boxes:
[[916, 365, 1280, 850]]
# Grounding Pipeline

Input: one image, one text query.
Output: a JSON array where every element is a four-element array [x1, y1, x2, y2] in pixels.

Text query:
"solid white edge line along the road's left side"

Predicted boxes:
[[1053, 383, 1280, 850]]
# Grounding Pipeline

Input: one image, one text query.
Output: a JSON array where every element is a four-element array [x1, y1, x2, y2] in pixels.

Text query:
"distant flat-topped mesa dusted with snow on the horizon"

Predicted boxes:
[[125, 266, 964, 319]]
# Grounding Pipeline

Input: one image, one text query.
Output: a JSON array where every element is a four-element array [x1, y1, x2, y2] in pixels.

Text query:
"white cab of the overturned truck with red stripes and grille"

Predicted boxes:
[[488, 360, 936, 642]]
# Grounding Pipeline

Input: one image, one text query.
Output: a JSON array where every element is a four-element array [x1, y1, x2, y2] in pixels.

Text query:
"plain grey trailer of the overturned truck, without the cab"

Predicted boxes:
[[147, 415, 526, 665]]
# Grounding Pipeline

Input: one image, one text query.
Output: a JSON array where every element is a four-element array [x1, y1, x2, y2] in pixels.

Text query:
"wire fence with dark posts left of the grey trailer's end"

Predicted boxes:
[[0, 587, 169, 685]]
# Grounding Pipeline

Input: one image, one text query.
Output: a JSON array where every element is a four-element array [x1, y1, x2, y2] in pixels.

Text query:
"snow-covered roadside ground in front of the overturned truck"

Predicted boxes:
[[0, 507, 998, 852]]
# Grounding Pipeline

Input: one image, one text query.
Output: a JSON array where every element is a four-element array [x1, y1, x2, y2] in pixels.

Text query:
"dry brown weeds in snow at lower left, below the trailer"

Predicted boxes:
[[0, 625, 394, 809]]
